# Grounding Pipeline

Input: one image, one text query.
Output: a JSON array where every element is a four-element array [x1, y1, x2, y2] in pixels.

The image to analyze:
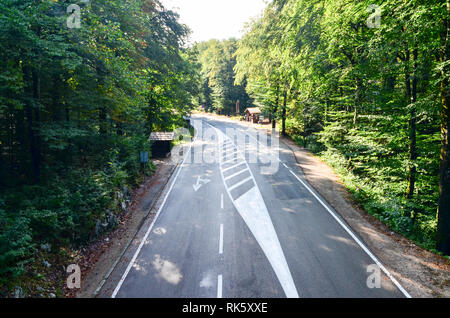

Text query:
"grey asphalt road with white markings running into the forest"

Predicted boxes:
[[98, 115, 409, 298]]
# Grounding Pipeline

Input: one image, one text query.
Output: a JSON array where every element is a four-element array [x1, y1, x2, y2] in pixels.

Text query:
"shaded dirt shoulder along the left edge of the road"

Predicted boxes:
[[72, 159, 176, 298]]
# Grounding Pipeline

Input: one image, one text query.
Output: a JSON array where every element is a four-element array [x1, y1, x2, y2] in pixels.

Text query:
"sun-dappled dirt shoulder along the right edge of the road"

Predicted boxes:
[[202, 114, 450, 298]]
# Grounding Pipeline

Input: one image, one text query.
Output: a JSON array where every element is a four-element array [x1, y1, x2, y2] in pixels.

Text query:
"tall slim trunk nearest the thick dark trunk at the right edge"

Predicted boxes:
[[406, 48, 418, 198]]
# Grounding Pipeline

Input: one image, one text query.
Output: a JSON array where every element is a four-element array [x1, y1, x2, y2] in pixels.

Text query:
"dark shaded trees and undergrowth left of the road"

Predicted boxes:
[[0, 0, 197, 297]]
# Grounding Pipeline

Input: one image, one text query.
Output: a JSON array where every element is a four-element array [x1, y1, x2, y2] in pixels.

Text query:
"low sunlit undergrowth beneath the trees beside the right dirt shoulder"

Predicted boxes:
[[309, 114, 439, 249]]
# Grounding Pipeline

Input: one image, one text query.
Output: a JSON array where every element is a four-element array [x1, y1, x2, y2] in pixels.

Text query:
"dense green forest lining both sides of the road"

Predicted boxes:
[[0, 0, 450, 295]]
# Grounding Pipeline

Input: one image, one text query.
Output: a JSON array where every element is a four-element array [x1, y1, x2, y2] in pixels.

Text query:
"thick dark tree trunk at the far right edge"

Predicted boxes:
[[436, 0, 450, 255]]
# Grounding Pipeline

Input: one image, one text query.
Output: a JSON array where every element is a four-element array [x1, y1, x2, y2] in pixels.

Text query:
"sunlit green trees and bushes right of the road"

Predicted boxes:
[[235, 0, 448, 253]]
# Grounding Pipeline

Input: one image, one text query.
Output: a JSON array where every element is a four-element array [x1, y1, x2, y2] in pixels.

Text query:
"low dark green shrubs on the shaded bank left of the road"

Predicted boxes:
[[0, 139, 142, 282]]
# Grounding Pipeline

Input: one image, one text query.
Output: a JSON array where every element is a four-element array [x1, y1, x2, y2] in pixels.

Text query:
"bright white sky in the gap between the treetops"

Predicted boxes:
[[160, 0, 266, 43]]
